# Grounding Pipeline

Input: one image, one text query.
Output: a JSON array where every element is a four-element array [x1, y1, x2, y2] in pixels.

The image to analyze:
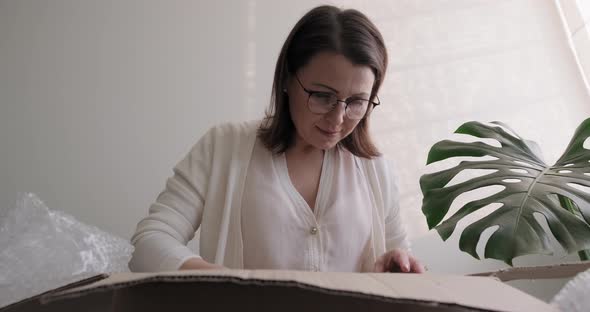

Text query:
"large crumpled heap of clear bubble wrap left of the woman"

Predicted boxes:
[[0, 193, 133, 308]]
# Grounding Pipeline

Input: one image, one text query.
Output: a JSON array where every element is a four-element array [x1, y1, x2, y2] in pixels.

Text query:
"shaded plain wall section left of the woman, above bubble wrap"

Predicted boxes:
[[0, 0, 254, 237]]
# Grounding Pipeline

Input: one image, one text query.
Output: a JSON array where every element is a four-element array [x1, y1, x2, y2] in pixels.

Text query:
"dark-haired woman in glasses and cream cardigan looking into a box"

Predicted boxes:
[[129, 6, 424, 272]]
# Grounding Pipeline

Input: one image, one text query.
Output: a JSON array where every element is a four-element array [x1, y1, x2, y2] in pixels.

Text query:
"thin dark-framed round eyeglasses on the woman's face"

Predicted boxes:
[[295, 75, 381, 120]]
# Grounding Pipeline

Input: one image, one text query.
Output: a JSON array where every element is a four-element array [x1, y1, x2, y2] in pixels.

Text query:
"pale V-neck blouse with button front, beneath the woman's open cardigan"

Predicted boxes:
[[241, 139, 373, 272]]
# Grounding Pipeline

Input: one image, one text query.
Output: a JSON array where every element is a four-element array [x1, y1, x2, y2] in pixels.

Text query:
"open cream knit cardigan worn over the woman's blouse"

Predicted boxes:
[[129, 121, 409, 272]]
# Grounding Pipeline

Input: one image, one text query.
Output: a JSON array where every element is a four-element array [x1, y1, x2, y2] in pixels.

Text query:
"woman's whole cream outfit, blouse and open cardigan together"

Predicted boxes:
[[129, 121, 409, 272]]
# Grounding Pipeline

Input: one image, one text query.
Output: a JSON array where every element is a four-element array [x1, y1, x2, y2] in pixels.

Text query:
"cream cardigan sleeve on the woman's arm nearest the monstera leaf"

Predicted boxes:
[[381, 159, 410, 250]]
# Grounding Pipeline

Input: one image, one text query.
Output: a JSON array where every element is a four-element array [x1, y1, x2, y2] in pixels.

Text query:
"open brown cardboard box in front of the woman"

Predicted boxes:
[[0, 270, 555, 312]]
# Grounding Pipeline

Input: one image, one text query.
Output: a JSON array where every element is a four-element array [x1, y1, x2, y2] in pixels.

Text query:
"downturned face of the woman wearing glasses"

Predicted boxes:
[[287, 52, 375, 150]]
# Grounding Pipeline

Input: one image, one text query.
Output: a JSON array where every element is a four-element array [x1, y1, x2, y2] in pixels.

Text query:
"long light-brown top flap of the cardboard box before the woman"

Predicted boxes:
[[42, 270, 555, 311]]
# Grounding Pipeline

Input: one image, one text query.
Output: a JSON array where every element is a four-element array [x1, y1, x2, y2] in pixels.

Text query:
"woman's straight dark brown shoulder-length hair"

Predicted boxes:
[[258, 6, 387, 158]]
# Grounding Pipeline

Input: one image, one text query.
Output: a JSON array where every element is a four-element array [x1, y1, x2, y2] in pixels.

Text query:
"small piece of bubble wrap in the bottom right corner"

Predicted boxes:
[[551, 264, 590, 312]]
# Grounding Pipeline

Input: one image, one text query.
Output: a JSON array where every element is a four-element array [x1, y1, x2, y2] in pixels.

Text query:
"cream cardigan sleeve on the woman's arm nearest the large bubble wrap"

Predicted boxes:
[[129, 126, 213, 272]]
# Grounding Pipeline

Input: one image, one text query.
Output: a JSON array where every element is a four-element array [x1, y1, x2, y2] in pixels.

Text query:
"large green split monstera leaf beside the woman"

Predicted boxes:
[[420, 118, 590, 265]]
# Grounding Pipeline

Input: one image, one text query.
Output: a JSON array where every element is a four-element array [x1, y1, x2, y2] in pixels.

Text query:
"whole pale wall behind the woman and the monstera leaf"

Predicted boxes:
[[0, 0, 590, 298]]
